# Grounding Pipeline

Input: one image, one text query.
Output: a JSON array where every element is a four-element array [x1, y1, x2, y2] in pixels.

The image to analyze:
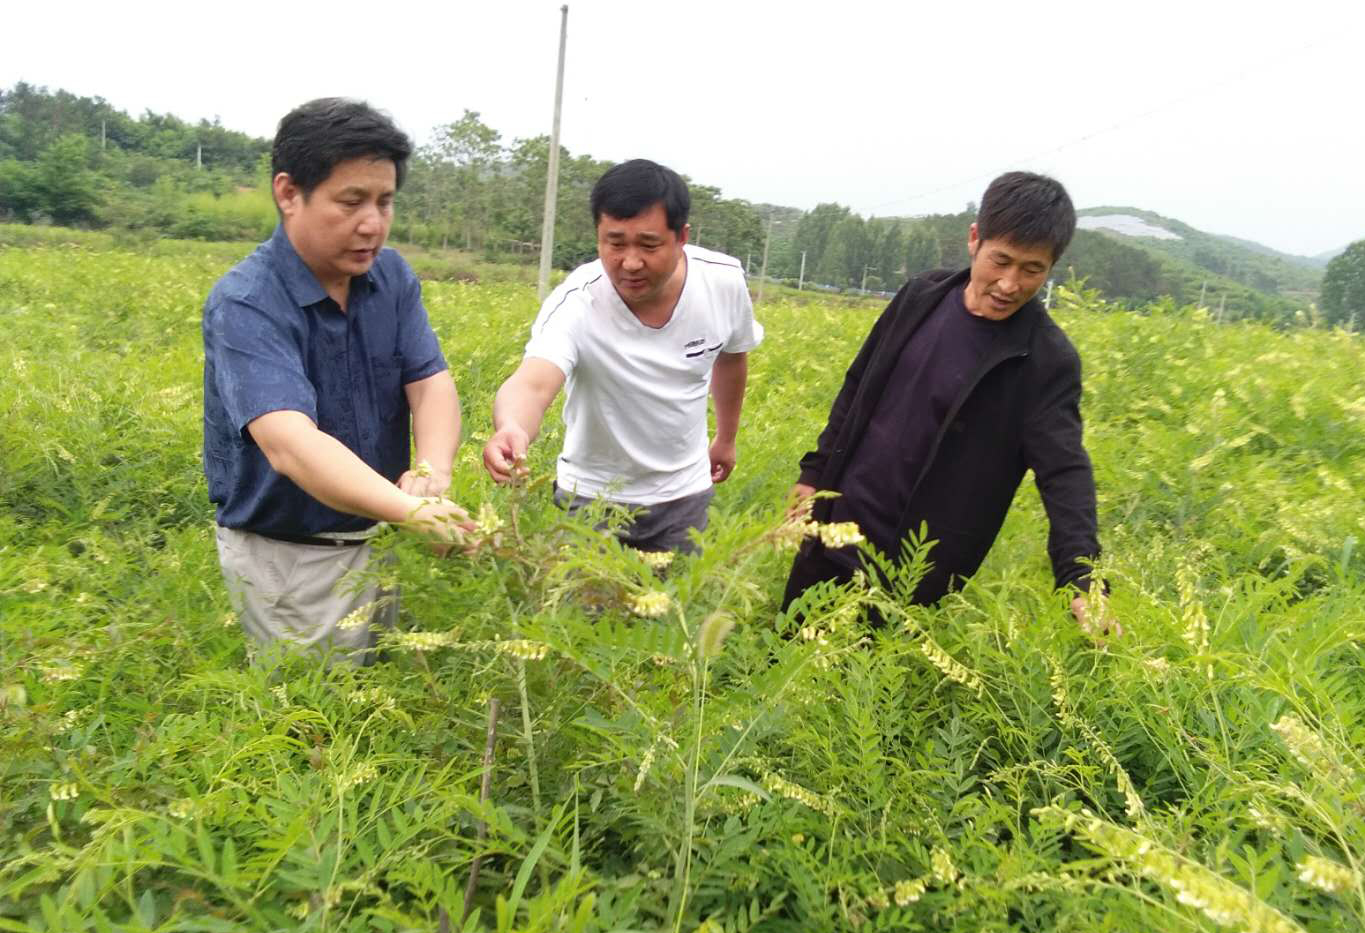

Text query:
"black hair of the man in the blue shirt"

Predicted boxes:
[[270, 97, 412, 198]]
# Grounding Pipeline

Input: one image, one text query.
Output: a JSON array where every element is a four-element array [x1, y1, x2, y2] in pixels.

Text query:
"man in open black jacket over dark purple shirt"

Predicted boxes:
[[782, 172, 1099, 625]]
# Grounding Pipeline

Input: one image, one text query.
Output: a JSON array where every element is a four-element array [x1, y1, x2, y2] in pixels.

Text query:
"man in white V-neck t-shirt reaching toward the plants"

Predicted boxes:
[[483, 160, 763, 551]]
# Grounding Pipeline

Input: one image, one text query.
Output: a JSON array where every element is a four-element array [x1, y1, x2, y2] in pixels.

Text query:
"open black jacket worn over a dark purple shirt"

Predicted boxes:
[[801, 270, 1099, 603]]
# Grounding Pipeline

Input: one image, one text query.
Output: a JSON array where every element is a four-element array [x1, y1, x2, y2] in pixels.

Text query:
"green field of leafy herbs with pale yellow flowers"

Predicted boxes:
[[0, 228, 1365, 933]]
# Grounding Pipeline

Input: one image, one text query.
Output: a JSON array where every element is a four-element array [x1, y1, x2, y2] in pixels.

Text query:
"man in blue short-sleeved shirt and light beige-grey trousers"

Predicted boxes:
[[203, 98, 468, 662]]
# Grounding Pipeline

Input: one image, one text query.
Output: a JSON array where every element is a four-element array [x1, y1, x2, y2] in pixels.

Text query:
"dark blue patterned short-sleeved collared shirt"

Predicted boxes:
[[203, 226, 446, 535]]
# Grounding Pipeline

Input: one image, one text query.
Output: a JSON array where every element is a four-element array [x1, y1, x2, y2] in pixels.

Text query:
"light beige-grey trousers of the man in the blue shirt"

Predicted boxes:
[[217, 525, 399, 664]]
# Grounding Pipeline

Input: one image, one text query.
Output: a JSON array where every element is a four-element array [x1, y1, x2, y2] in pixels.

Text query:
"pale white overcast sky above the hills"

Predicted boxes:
[[0, 0, 1365, 255]]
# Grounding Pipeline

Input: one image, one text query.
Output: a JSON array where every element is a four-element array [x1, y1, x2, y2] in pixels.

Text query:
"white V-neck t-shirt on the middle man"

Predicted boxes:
[[526, 244, 763, 505]]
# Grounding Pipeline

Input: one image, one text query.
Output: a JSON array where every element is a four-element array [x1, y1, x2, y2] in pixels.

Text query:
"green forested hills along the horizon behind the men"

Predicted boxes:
[[0, 82, 1321, 323]]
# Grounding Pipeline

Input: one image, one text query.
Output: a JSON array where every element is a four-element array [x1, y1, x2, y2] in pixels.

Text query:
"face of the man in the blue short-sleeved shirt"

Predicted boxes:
[[274, 157, 397, 286]]
